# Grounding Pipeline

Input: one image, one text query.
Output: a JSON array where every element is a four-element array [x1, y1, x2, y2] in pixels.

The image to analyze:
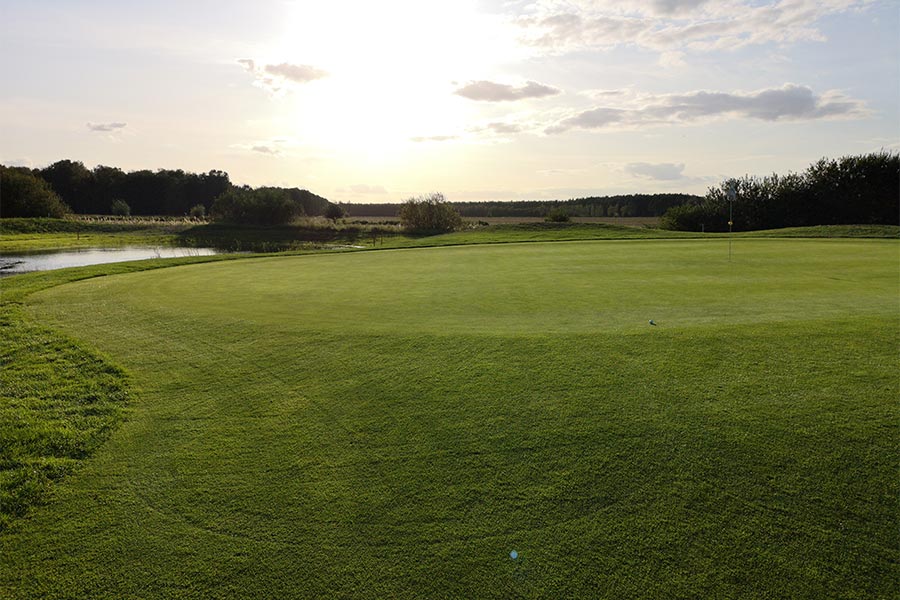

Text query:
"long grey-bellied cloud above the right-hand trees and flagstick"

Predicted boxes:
[[546, 83, 867, 134]]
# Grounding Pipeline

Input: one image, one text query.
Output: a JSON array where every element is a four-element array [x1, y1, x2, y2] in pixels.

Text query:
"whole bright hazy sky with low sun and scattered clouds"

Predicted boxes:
[[0, 0, 900, 202]]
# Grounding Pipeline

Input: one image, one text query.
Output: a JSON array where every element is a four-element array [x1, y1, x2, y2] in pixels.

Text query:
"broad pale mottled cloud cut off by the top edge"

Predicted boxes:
[[516, 0, 869, 52]]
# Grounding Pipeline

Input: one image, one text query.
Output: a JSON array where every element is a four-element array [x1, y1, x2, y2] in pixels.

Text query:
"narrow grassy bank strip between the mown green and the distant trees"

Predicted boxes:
[[0, 217, 900, 254]]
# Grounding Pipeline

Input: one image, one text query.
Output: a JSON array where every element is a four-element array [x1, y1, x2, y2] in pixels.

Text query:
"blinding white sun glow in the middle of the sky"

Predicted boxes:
[[266, 1, 519, 154]]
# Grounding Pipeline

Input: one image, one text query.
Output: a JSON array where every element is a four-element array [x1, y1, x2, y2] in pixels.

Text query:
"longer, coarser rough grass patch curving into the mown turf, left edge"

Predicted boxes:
[[0, 303, 128, 531]]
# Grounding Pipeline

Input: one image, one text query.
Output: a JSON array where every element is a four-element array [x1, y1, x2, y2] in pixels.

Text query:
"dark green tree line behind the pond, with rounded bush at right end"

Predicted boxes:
[[0, 160, 330, 223]]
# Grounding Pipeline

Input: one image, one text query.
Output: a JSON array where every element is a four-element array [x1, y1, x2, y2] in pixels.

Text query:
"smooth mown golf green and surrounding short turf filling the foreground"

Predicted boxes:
[[0, 240, 900, 598]]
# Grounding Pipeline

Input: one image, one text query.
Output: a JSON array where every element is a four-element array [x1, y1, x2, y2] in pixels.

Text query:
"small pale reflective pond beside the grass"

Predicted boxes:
[[0, 246, 223, 275]]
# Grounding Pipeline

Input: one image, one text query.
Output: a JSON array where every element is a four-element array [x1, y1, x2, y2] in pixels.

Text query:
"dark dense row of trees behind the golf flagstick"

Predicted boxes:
[[660, 151, 900, 231]]
